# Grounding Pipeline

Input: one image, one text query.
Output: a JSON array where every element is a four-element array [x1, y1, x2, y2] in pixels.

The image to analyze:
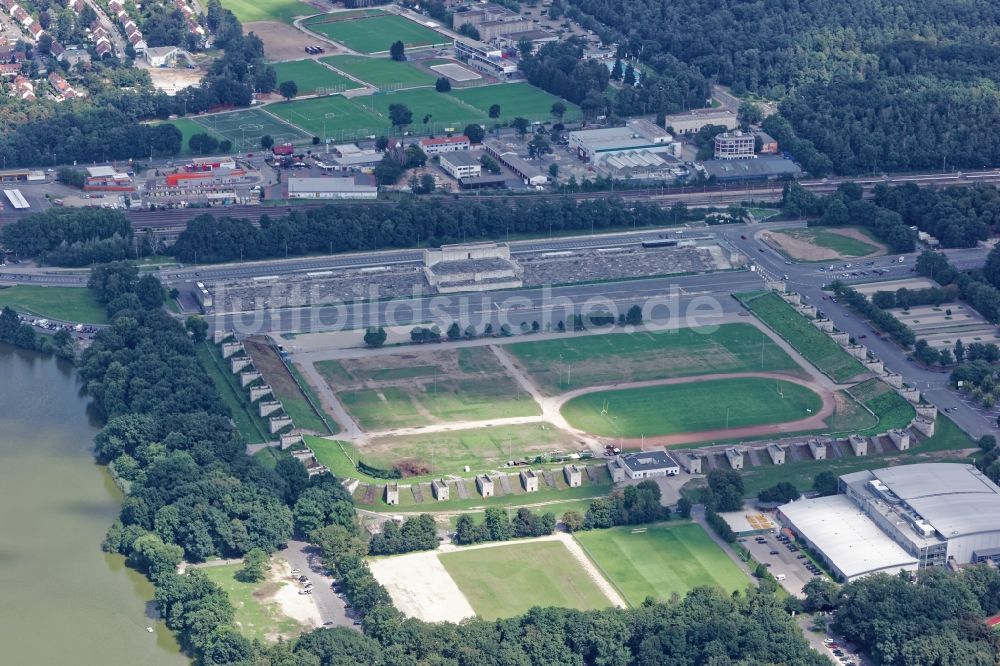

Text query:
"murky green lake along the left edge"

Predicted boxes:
[[0, 345, 188, 666]]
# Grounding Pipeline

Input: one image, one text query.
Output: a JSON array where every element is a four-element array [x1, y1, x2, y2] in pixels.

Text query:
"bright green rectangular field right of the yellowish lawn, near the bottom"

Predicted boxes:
[[574, 523, 750, 606]]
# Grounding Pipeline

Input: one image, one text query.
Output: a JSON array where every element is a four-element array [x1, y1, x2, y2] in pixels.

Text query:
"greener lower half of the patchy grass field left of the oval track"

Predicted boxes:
[[337, 376, 541, 430]]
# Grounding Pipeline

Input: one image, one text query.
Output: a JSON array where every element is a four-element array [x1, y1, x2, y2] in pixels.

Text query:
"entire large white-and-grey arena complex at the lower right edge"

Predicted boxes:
[[778, 463, 1000, 581]]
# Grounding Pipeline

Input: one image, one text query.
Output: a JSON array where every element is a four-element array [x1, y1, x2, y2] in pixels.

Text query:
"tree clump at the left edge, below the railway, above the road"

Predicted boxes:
[[0, 208, 137, 266]]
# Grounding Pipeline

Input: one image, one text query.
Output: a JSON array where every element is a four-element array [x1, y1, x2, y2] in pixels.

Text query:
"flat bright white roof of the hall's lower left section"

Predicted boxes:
[[779, 495, 917, 579]]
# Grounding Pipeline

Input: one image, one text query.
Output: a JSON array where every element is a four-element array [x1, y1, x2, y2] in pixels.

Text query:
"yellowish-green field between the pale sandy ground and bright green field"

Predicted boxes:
[[438, 541, 611, 620]]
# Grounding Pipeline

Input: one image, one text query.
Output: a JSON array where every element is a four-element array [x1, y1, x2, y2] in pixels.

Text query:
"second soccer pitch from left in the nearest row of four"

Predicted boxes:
[[267, 95, 391, 141]]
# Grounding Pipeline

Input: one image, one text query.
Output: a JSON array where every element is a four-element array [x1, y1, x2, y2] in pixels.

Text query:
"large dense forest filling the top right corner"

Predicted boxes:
[[569, 0, 1000, 176]]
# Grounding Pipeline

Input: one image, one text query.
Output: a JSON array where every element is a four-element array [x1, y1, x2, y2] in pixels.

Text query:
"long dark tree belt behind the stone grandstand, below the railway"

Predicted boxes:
[[170, 198, 672, 262]]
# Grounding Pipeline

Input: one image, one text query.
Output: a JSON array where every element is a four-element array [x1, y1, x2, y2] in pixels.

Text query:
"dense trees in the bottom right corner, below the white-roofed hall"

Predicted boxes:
[[834, 565, 1000, 666]]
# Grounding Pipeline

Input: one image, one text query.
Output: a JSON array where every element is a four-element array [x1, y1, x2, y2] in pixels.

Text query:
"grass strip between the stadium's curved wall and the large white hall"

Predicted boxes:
[[743, 415, 976, 496]]
